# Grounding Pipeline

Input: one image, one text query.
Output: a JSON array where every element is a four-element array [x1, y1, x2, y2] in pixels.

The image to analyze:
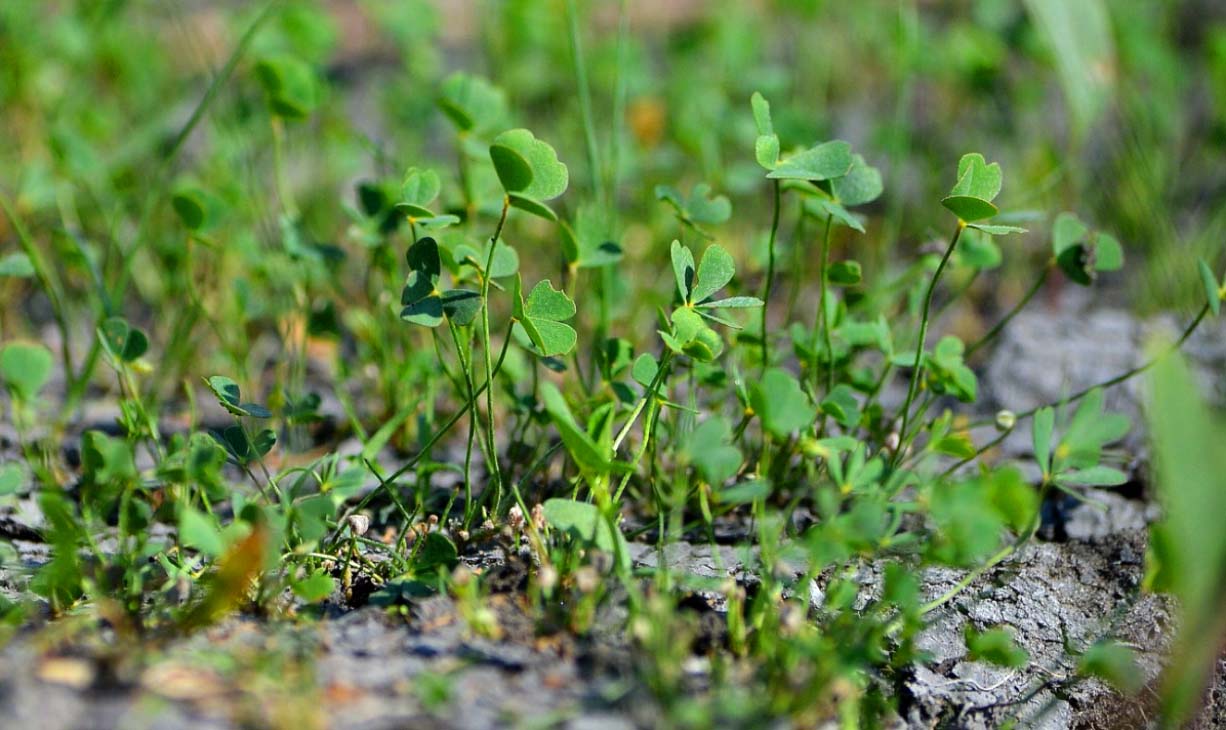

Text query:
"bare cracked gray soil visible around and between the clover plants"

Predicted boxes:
[[0, 305, 1226, 730]]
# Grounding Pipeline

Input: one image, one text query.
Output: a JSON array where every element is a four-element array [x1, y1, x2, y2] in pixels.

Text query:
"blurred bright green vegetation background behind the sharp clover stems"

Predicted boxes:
[[0, 0, 1226, 347]]
